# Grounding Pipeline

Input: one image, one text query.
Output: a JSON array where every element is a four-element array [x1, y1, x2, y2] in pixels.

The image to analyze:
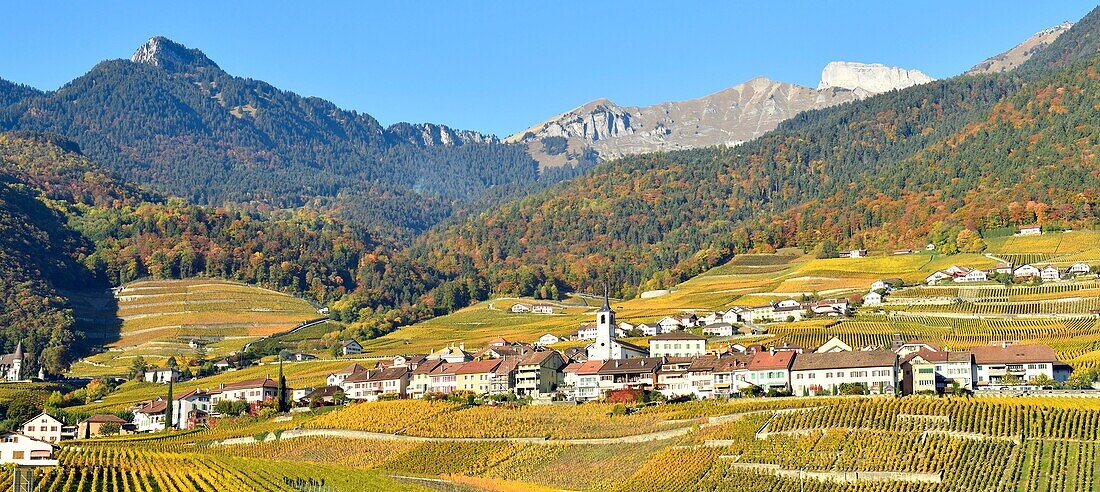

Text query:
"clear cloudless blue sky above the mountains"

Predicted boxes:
[[0, 0, 1096, 135]]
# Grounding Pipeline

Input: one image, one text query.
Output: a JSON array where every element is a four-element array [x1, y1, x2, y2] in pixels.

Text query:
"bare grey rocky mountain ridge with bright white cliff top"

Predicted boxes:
[[505, 62, 932, 166]]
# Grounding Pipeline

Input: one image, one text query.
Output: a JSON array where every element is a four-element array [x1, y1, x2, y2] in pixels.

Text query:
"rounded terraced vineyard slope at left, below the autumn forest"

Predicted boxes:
[[72, 278, 318, 376]]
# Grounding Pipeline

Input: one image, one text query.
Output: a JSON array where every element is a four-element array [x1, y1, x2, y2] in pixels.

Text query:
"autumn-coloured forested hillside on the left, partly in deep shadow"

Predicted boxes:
[[0, 133, 441, 372]]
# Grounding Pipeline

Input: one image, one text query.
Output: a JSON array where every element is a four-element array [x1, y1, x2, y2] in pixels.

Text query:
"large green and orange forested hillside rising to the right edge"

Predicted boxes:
[[415, 7, 1100, 295]]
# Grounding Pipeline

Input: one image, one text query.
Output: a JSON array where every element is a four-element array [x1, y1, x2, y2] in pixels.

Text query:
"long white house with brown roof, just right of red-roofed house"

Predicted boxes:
[[791, 350, 898, 395]]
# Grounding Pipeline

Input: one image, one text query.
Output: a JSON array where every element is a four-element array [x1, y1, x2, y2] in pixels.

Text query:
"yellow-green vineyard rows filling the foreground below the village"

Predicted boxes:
[[42, 396, 1100, 492]]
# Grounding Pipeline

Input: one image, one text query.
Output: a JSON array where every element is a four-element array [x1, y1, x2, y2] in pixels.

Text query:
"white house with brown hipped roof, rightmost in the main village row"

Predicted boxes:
[[970, 343, 1065, 387]]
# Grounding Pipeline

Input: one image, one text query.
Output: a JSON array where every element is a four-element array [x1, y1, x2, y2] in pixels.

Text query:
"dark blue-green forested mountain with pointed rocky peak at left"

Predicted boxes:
[[0, 37, 540, 236]]
